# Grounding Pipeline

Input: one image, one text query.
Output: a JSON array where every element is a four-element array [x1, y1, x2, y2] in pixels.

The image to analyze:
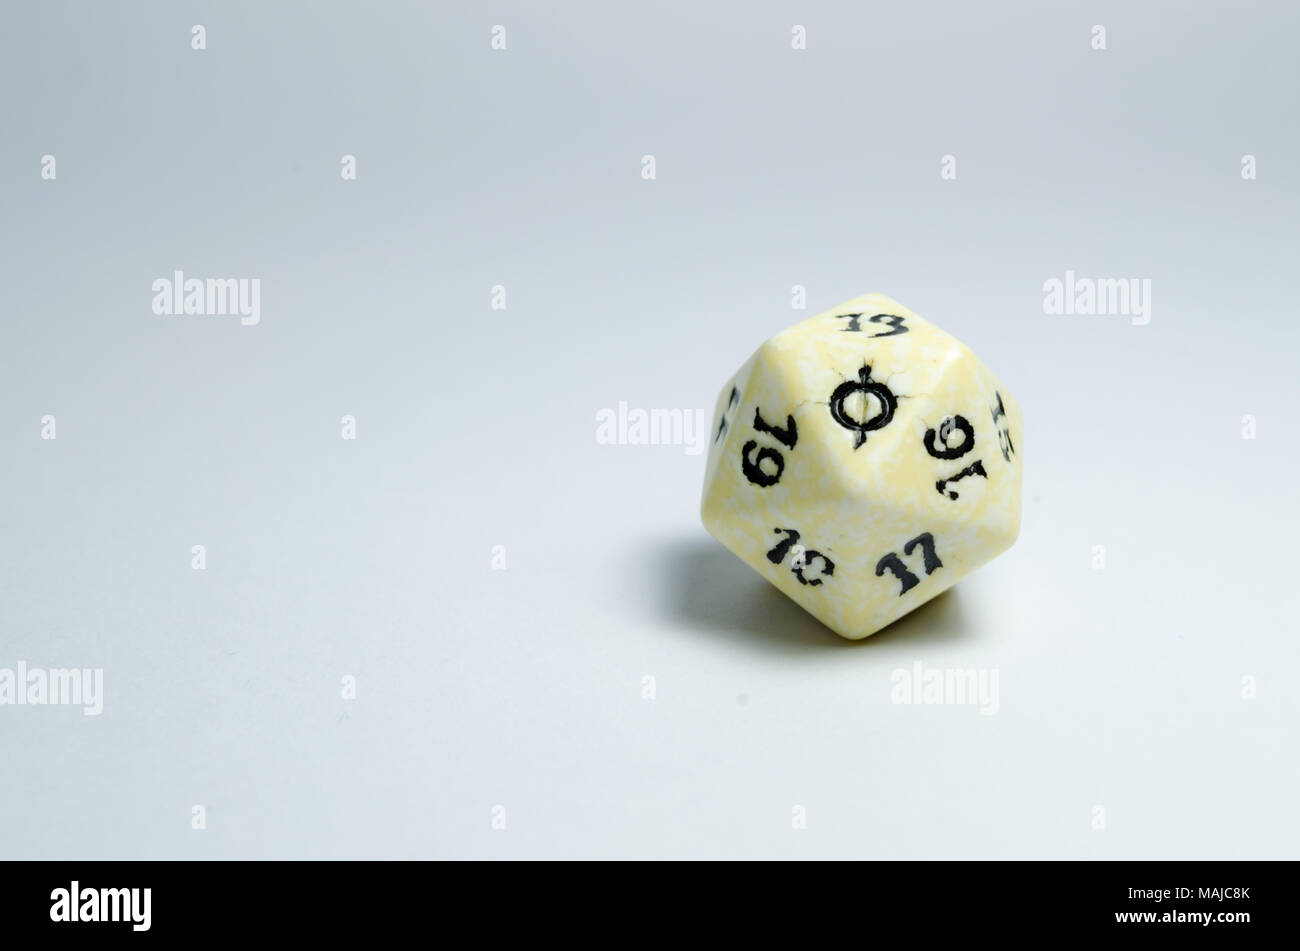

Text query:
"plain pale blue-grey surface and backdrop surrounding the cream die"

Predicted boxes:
[[0, 3, 1300, 857]]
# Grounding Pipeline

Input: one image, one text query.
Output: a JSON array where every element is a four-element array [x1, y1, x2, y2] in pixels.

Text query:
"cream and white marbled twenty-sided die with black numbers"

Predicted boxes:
[[701, 294, 1023, 639]]
